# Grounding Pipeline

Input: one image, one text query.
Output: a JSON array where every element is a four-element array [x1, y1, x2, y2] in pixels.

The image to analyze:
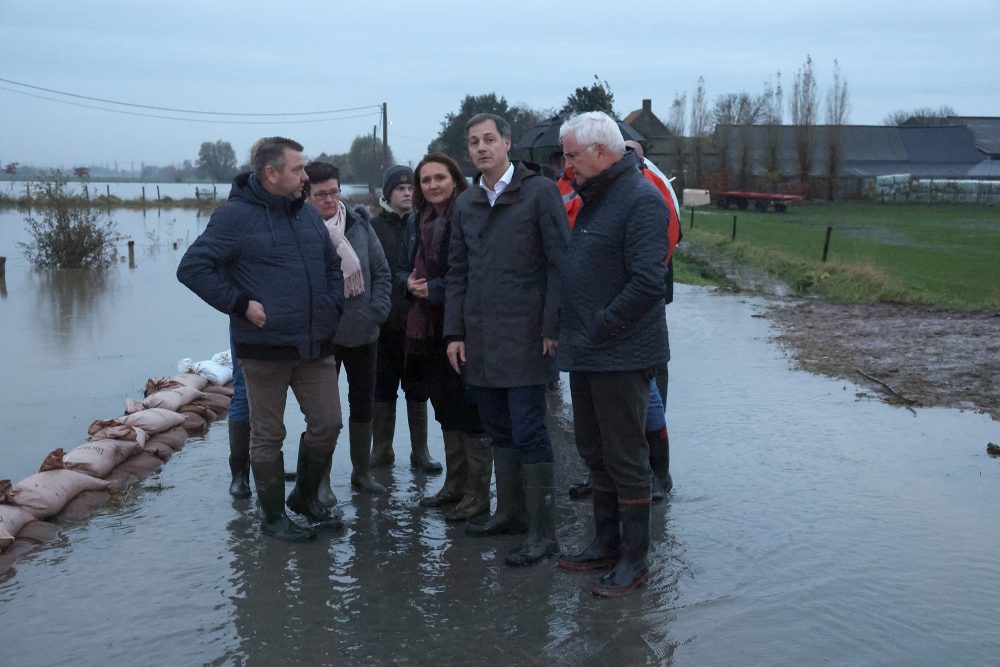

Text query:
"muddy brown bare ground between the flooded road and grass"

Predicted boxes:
[[768, 299, 1000, 420]]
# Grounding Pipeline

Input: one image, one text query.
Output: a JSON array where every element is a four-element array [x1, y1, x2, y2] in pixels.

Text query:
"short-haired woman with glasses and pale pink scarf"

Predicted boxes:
[[306, 162, 392, 496]]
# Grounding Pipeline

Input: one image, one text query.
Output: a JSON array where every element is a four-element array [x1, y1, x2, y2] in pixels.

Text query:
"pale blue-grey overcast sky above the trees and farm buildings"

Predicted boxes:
[[0, 0, 1000, 168]]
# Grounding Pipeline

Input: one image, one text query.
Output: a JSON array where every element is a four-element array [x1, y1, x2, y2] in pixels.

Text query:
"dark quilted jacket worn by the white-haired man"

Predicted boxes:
[[556, 154, 669, 371]]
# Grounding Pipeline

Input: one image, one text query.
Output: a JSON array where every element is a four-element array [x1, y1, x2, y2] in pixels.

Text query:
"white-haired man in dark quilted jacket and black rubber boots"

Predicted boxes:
[[556, 112, 668, 597]]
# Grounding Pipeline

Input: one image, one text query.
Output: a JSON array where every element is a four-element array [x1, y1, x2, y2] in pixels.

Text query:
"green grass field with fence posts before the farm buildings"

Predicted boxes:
[[678, 203, 1000, 309]]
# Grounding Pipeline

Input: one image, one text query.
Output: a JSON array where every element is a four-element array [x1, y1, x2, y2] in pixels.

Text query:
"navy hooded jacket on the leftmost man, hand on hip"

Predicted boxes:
[[177, 174, 344, 359]]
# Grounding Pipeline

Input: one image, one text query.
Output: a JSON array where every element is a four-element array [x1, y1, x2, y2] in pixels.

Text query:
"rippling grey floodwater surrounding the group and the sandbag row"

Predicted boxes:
[[0, 211, 1000, 665]]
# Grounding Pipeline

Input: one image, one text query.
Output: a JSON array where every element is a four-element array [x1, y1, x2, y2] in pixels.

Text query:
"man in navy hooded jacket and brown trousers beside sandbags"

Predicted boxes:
[[177, 137, 344, 541]]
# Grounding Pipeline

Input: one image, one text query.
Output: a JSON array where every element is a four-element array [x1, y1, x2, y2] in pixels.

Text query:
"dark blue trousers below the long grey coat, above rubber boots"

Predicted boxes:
[[470, 384, 553, 464]]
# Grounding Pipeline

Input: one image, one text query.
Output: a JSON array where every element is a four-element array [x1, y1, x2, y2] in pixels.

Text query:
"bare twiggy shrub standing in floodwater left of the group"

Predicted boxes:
[[18, 171, 123, 269]]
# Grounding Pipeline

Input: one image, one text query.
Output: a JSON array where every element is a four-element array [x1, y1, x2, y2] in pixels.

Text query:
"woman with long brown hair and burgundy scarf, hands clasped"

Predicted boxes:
[[394, 153, 493, 521]]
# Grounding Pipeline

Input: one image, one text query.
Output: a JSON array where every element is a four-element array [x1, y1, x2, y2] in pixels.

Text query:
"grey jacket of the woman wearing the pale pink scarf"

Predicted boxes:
[[333, 209, 392, 347]]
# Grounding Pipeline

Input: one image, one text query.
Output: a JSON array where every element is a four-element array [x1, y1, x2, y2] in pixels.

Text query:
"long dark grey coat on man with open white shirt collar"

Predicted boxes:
[[444, 162, 569, 387]]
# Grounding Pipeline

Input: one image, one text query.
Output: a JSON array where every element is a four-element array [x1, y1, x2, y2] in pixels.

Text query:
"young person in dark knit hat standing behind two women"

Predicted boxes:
[[371, 164, 441, 472]]
